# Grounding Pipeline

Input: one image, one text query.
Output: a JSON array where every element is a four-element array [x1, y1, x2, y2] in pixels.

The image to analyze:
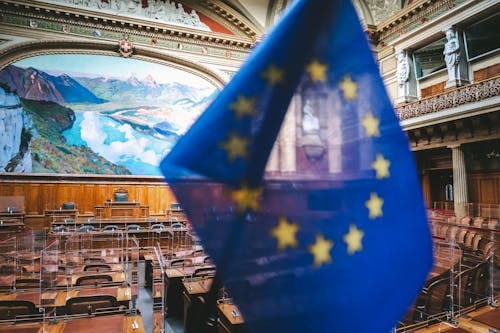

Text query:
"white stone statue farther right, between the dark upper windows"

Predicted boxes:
[[443, 27, 470, 88]]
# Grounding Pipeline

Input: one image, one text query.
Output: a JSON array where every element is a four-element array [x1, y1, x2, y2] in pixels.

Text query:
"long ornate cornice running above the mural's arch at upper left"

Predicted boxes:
[[0, 0, 254, 52]]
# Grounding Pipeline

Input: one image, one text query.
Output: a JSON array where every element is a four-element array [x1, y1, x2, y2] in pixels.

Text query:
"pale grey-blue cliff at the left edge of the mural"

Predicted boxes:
[[0, 87, 32, 172]]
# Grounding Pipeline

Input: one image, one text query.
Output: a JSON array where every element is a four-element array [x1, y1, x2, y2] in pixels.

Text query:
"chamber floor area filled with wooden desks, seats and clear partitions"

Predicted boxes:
[[0, 204, 500, 333]]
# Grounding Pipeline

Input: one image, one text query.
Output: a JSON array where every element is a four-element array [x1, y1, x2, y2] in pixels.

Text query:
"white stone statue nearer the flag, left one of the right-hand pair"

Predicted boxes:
[[396, 50, 417, 104]]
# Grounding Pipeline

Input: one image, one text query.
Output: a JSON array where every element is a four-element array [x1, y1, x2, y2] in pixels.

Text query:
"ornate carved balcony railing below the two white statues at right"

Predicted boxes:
[[396, 76, 500, 120]]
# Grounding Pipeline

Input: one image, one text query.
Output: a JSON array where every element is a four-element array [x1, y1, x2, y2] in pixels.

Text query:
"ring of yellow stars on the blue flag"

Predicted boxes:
[[220, 54, 391, 268]]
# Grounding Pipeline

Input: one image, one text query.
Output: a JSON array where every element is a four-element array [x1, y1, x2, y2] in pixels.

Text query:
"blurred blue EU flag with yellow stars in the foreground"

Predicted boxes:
[[161, 0, 432, 333]]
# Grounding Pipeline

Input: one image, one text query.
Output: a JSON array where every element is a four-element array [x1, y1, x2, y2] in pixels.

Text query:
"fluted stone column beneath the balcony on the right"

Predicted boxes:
[[449, 145, 468, 220]]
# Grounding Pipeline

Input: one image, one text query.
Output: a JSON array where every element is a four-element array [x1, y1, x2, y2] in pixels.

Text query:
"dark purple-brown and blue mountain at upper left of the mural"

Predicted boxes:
[[0, 65, 105, 104]]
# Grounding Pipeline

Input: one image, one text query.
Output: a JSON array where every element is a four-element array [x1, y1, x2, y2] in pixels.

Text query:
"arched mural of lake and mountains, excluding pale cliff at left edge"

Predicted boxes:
[[0, 54, 218, 175]]
